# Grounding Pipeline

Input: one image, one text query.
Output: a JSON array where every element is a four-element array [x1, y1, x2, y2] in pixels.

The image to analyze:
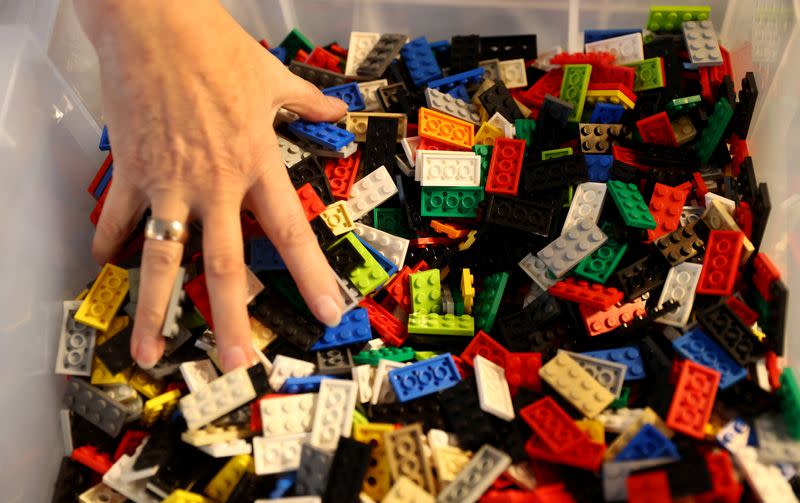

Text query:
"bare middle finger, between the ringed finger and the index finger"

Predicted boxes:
[[203, 200, 256, 372]]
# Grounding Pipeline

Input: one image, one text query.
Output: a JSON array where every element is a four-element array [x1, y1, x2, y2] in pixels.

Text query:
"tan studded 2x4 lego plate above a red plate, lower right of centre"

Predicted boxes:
[[539, 351, 615, 419]]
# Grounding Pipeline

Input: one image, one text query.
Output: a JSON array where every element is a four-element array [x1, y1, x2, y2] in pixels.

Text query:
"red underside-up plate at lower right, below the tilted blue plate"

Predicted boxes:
[[666, 360, 720, 440]]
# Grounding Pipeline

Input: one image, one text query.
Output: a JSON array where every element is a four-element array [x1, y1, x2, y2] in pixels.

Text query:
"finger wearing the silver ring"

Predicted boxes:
[[131, 196, 189, 369]]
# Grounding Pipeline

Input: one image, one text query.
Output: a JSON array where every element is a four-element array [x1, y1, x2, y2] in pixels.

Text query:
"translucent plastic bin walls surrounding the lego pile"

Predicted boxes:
[[0, 0, 800, 502]]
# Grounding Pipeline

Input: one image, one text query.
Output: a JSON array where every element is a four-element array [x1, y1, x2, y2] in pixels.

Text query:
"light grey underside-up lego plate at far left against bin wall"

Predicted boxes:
[[56, 300, 97, 377]]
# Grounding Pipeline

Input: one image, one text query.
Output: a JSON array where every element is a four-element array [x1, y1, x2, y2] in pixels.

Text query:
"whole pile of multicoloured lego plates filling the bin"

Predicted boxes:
[[54, 7, 800, 503]]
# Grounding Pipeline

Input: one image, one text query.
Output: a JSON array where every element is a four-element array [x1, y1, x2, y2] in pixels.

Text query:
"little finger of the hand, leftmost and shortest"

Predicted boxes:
[[92, 178, 145, 264]]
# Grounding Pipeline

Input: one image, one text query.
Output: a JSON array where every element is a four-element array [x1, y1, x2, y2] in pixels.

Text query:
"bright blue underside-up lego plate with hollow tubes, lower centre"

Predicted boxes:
[[389, 353, 461, 402]]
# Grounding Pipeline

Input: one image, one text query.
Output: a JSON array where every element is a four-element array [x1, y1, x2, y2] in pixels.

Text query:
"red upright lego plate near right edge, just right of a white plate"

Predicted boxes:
[[697, 231, 744, 295]]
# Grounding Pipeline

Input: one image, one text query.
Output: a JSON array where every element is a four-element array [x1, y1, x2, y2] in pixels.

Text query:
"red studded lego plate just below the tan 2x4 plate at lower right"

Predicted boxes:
[[519, 396, 589, 454]]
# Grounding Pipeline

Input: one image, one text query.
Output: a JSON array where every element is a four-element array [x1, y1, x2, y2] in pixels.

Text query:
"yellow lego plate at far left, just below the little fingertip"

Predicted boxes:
[[75, 264, 128, 330]]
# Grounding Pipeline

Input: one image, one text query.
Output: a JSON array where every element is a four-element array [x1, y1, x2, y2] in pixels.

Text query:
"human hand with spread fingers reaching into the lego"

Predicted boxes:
[[75, 0, 347, 371]]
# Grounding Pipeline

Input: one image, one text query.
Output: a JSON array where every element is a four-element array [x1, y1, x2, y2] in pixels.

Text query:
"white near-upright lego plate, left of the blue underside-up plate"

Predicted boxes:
[[311, 379, 358, 451]]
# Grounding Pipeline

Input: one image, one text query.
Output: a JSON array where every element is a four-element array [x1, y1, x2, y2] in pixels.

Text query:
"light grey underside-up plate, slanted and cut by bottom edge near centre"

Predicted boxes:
[[436, 444, 511, 503]]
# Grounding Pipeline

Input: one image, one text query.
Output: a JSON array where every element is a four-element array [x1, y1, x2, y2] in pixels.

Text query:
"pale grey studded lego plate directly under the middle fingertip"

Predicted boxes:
[[180, 367, 256, 430]]
